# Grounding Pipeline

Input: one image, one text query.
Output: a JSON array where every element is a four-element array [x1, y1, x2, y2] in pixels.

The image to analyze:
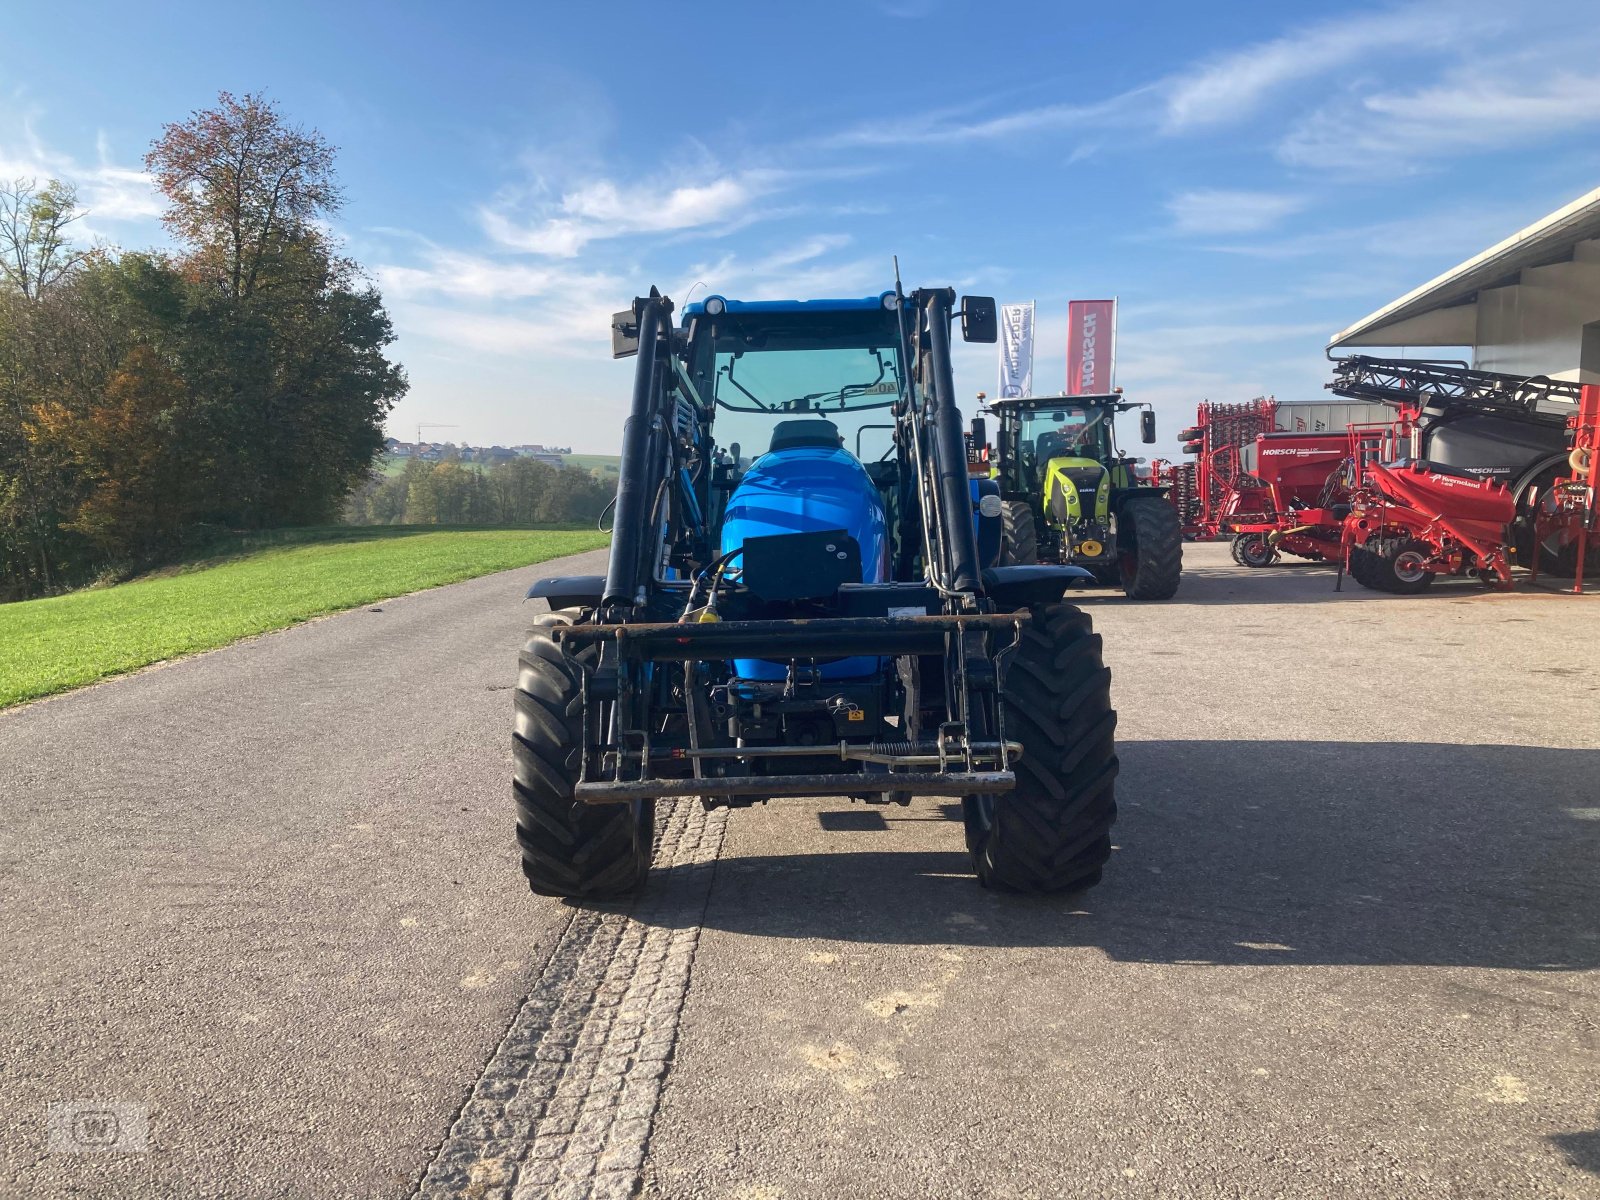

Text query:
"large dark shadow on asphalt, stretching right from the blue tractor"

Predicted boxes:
[[633, 748, 1600, 972]]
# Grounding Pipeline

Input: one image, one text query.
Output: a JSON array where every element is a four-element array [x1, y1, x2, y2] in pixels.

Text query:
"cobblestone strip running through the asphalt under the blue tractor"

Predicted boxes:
[[418, 800, 728, 1200]]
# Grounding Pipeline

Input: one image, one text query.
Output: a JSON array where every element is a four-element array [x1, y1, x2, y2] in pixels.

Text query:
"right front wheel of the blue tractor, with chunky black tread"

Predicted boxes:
[[962, 603, 1117, 893]]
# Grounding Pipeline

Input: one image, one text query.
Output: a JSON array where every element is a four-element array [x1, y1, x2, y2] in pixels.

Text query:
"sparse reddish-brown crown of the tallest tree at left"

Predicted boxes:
[[144, 91, 342, 299]]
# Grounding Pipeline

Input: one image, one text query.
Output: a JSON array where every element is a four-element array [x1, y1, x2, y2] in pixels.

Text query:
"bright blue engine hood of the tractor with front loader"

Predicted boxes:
[[722, 438, 890, 680]]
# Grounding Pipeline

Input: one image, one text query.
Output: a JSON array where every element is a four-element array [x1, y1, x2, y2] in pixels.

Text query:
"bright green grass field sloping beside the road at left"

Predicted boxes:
[[0, 525, 608, 707]]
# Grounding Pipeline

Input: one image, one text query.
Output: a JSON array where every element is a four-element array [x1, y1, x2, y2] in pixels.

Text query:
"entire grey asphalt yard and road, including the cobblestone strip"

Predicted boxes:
[[0, 546, 1600, 1200]]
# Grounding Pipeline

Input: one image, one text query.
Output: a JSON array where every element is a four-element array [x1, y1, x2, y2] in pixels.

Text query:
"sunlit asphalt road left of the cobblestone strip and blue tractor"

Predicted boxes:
[[0, 552, 605, 1197]]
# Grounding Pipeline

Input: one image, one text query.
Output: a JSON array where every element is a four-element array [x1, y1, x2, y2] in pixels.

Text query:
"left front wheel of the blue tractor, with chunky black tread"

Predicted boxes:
[[512, 611, 656, 898]]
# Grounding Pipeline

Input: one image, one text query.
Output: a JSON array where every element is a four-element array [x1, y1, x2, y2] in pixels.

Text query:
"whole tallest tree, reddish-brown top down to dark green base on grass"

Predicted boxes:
[[146, 93, 406, 526]]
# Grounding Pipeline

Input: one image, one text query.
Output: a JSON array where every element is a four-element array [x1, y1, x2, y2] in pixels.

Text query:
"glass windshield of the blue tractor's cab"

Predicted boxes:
[[696, 314, 902, 459]]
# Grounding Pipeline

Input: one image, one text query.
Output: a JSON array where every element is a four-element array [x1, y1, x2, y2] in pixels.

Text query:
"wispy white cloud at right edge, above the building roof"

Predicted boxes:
[[1278, 66, 1600, 171]]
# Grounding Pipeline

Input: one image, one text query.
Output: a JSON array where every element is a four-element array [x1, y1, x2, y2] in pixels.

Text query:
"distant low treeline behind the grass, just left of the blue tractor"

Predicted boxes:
[[344, 458, 616, 525]]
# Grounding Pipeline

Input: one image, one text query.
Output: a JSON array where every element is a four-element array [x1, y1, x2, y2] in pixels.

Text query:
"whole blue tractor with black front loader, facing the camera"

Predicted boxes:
[[512, 283, 1117, 896]]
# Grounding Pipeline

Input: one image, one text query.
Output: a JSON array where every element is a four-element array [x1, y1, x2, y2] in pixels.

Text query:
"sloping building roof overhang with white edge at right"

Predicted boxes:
[[1328, 187, 1600, 350]]
